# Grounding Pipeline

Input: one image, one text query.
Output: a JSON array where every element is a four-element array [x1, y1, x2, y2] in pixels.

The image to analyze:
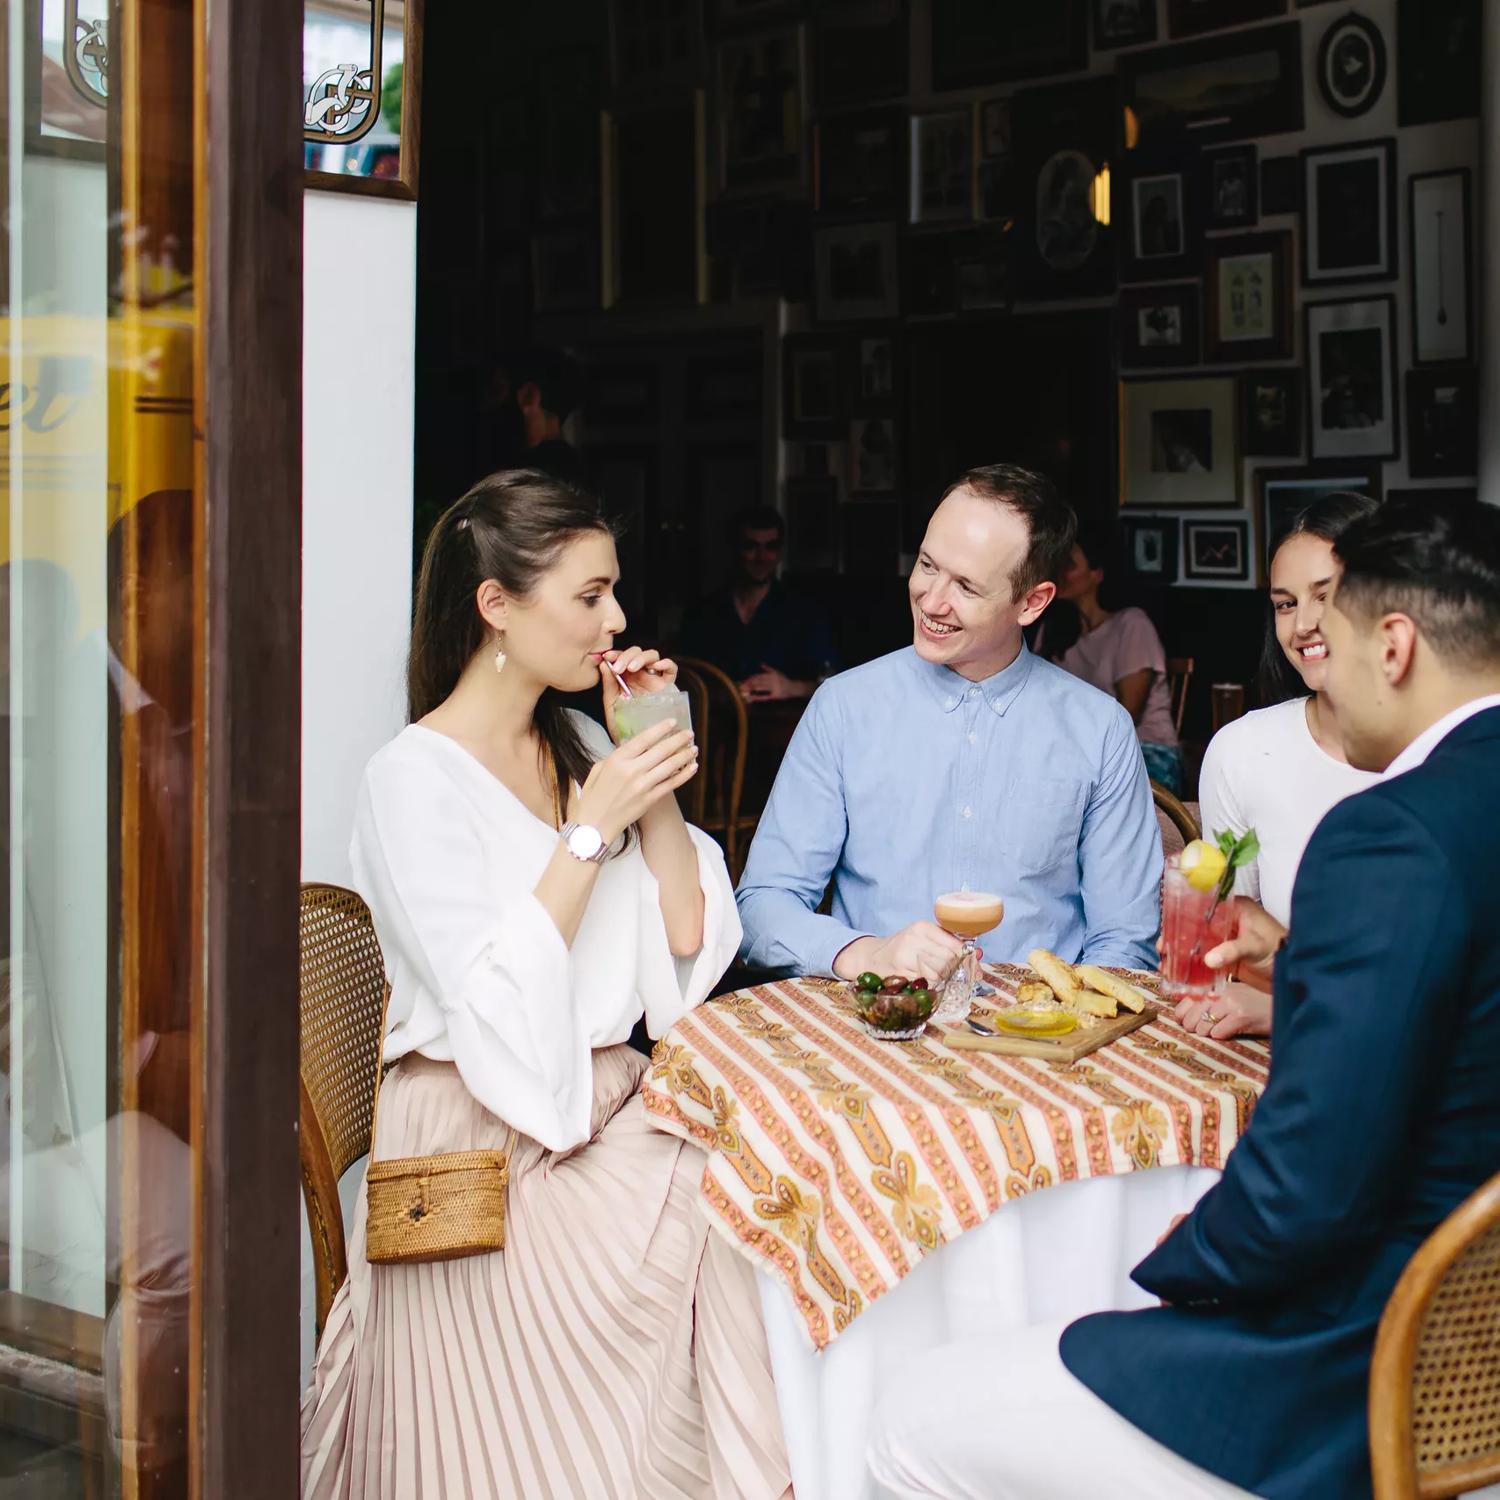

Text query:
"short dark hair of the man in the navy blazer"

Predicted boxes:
[[1334, 495, 1500, 668]]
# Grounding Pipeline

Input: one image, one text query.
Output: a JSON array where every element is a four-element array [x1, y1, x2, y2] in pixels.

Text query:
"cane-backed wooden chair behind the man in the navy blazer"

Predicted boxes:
[[1370, 1176, 1500, 1500]]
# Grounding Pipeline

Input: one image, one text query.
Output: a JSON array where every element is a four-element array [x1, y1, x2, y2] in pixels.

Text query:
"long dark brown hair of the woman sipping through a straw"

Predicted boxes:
[[407, 470, 614, 812]]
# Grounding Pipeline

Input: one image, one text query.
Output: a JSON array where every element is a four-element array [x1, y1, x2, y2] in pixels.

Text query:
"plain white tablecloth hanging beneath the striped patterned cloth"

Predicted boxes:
[[761, 1167, 1218, 1500]]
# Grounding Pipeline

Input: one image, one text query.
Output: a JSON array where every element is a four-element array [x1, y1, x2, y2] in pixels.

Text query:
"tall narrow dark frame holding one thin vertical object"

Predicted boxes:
[[1407, 168, 1473, 365]]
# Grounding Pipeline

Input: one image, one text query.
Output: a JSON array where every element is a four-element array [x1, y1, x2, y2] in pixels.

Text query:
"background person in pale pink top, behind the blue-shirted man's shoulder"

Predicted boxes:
[[1038, 534, 1182, 792]]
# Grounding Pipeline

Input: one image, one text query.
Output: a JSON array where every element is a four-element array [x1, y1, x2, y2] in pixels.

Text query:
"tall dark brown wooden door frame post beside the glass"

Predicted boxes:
[[192, 0, 303, 1500]]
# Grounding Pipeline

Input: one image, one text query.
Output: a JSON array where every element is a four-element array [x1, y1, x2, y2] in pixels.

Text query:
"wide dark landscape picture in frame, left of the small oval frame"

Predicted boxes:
[[1119, 21, 1304, 146]]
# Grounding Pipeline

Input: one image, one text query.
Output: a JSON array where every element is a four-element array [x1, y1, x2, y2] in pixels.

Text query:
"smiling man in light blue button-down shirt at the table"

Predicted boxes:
[[737, 464, 1161, 980]]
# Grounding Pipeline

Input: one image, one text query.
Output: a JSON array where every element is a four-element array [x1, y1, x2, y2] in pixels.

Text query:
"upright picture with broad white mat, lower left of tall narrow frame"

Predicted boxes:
[[1302, 294, 1401, 459]]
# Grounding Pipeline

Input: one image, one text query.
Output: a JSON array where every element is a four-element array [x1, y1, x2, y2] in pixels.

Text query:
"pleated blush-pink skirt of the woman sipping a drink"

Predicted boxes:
[[302, 1047, 791, 1500]]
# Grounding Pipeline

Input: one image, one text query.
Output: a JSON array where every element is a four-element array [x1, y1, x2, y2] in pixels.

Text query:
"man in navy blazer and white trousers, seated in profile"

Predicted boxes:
[[870, 500, 1500, 1500]]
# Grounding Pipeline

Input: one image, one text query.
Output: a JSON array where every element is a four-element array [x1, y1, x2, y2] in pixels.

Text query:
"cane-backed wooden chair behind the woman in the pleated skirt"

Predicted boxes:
[[300, 885, 386, 1338]]
